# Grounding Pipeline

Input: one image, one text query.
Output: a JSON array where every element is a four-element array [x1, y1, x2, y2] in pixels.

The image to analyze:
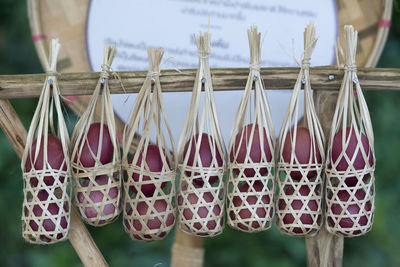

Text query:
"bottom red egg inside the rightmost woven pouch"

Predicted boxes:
[[328, 189, 371, 231]]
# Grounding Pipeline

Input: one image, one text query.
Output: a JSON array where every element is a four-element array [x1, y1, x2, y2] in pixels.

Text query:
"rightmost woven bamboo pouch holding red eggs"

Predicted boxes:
[[325, 26, 375, 237]]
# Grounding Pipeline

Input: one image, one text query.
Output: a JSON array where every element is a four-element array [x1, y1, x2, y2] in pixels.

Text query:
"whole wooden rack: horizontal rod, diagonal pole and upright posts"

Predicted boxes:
[[0, 67, 400, 266]]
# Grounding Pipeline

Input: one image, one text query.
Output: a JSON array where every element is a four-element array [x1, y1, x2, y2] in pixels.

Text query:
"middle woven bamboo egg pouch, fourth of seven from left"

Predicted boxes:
[[178, 32, 225, 236]]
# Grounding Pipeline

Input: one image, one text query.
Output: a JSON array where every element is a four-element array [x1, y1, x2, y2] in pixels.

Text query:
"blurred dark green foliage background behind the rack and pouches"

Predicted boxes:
[[0, 0, 400, 266]]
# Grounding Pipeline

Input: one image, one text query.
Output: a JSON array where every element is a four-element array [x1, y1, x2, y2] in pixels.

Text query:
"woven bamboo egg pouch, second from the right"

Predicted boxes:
[[276, 22, 325, 236]]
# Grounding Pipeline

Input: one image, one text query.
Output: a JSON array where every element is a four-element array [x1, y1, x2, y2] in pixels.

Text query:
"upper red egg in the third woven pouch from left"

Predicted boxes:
[[129, 145, 170, 197]]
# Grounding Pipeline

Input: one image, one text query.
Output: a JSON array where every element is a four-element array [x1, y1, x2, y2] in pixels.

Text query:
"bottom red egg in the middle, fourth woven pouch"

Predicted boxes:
[[178, 192, 221, 235]]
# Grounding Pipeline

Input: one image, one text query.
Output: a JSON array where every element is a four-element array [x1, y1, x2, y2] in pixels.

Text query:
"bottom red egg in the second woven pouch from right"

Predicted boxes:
[[279, 185, 321, 234]]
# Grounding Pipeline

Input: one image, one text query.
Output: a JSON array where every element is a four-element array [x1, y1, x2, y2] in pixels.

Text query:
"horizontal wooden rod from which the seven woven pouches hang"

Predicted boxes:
[[0, 66, 400, 98]]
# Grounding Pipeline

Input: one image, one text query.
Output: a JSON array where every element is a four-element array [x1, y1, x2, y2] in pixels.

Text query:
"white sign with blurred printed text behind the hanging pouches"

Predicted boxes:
[[87, 0, 338, 142]]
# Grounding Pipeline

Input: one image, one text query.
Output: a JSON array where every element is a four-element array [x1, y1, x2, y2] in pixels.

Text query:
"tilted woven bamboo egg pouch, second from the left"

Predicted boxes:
[[71, 45, 121, 226]]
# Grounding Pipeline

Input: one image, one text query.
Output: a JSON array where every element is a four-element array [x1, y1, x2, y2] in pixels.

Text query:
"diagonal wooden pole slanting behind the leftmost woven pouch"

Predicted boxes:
[[0, 99, 108, 267]]
